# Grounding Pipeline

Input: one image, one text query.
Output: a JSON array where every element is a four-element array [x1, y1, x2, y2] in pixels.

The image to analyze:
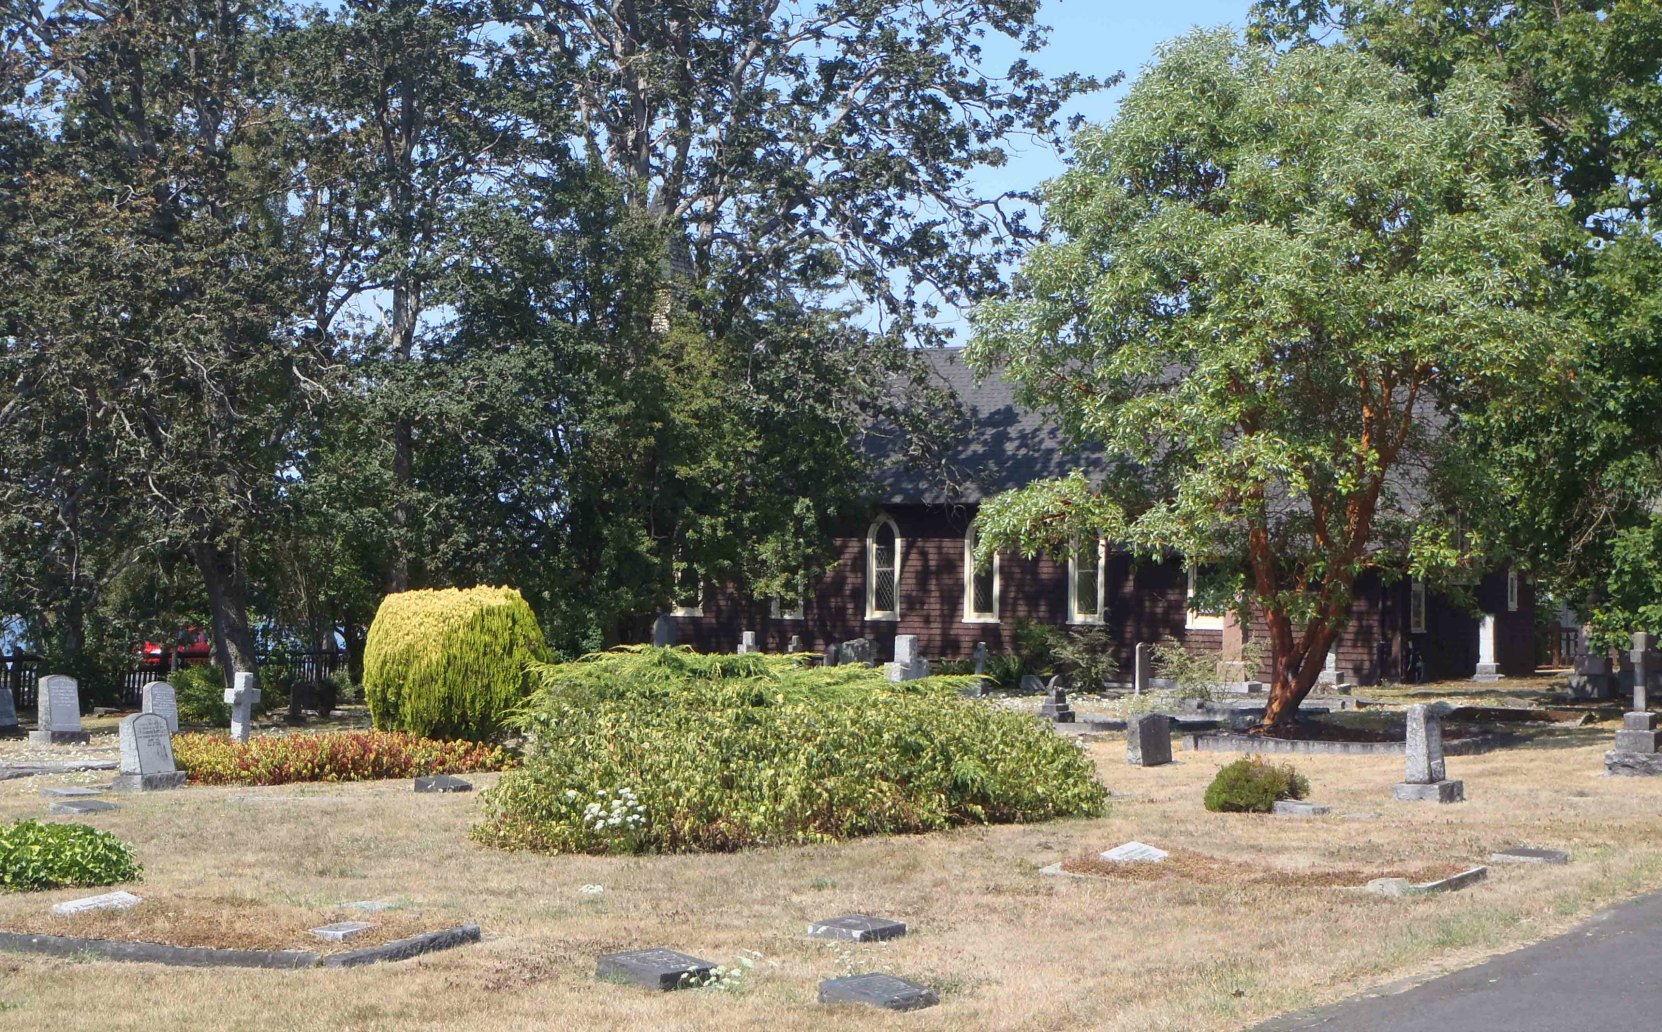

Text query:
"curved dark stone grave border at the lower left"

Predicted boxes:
[[0, 924, 480, 971]]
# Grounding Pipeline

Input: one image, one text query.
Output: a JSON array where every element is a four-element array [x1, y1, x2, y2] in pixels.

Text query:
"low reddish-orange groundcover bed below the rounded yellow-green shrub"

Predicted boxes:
[[173, 731, 512, 784]]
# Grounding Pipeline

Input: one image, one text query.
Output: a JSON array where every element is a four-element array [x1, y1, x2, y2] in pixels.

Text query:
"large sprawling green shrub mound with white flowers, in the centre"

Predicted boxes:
[[474, 646, 1107, 853]]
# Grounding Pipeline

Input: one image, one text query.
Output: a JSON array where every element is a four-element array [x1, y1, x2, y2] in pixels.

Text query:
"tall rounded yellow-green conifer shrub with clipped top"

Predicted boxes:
[[364, 588, 547, 741]]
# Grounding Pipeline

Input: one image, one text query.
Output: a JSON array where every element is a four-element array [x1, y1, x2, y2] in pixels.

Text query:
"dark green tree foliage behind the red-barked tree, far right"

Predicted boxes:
[[1255, 0, 1662, 638]]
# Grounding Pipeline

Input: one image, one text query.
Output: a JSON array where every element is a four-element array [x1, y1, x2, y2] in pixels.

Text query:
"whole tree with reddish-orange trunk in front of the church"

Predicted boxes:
[[971, 32, 1574, 725]]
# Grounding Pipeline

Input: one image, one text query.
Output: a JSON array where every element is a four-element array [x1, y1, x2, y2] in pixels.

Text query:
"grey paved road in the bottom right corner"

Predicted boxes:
[[1251, 892, 1662, 1032]]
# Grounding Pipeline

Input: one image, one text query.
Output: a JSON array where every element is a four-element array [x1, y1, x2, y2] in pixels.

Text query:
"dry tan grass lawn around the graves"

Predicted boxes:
[[0, 717, 1662, 1032]]
